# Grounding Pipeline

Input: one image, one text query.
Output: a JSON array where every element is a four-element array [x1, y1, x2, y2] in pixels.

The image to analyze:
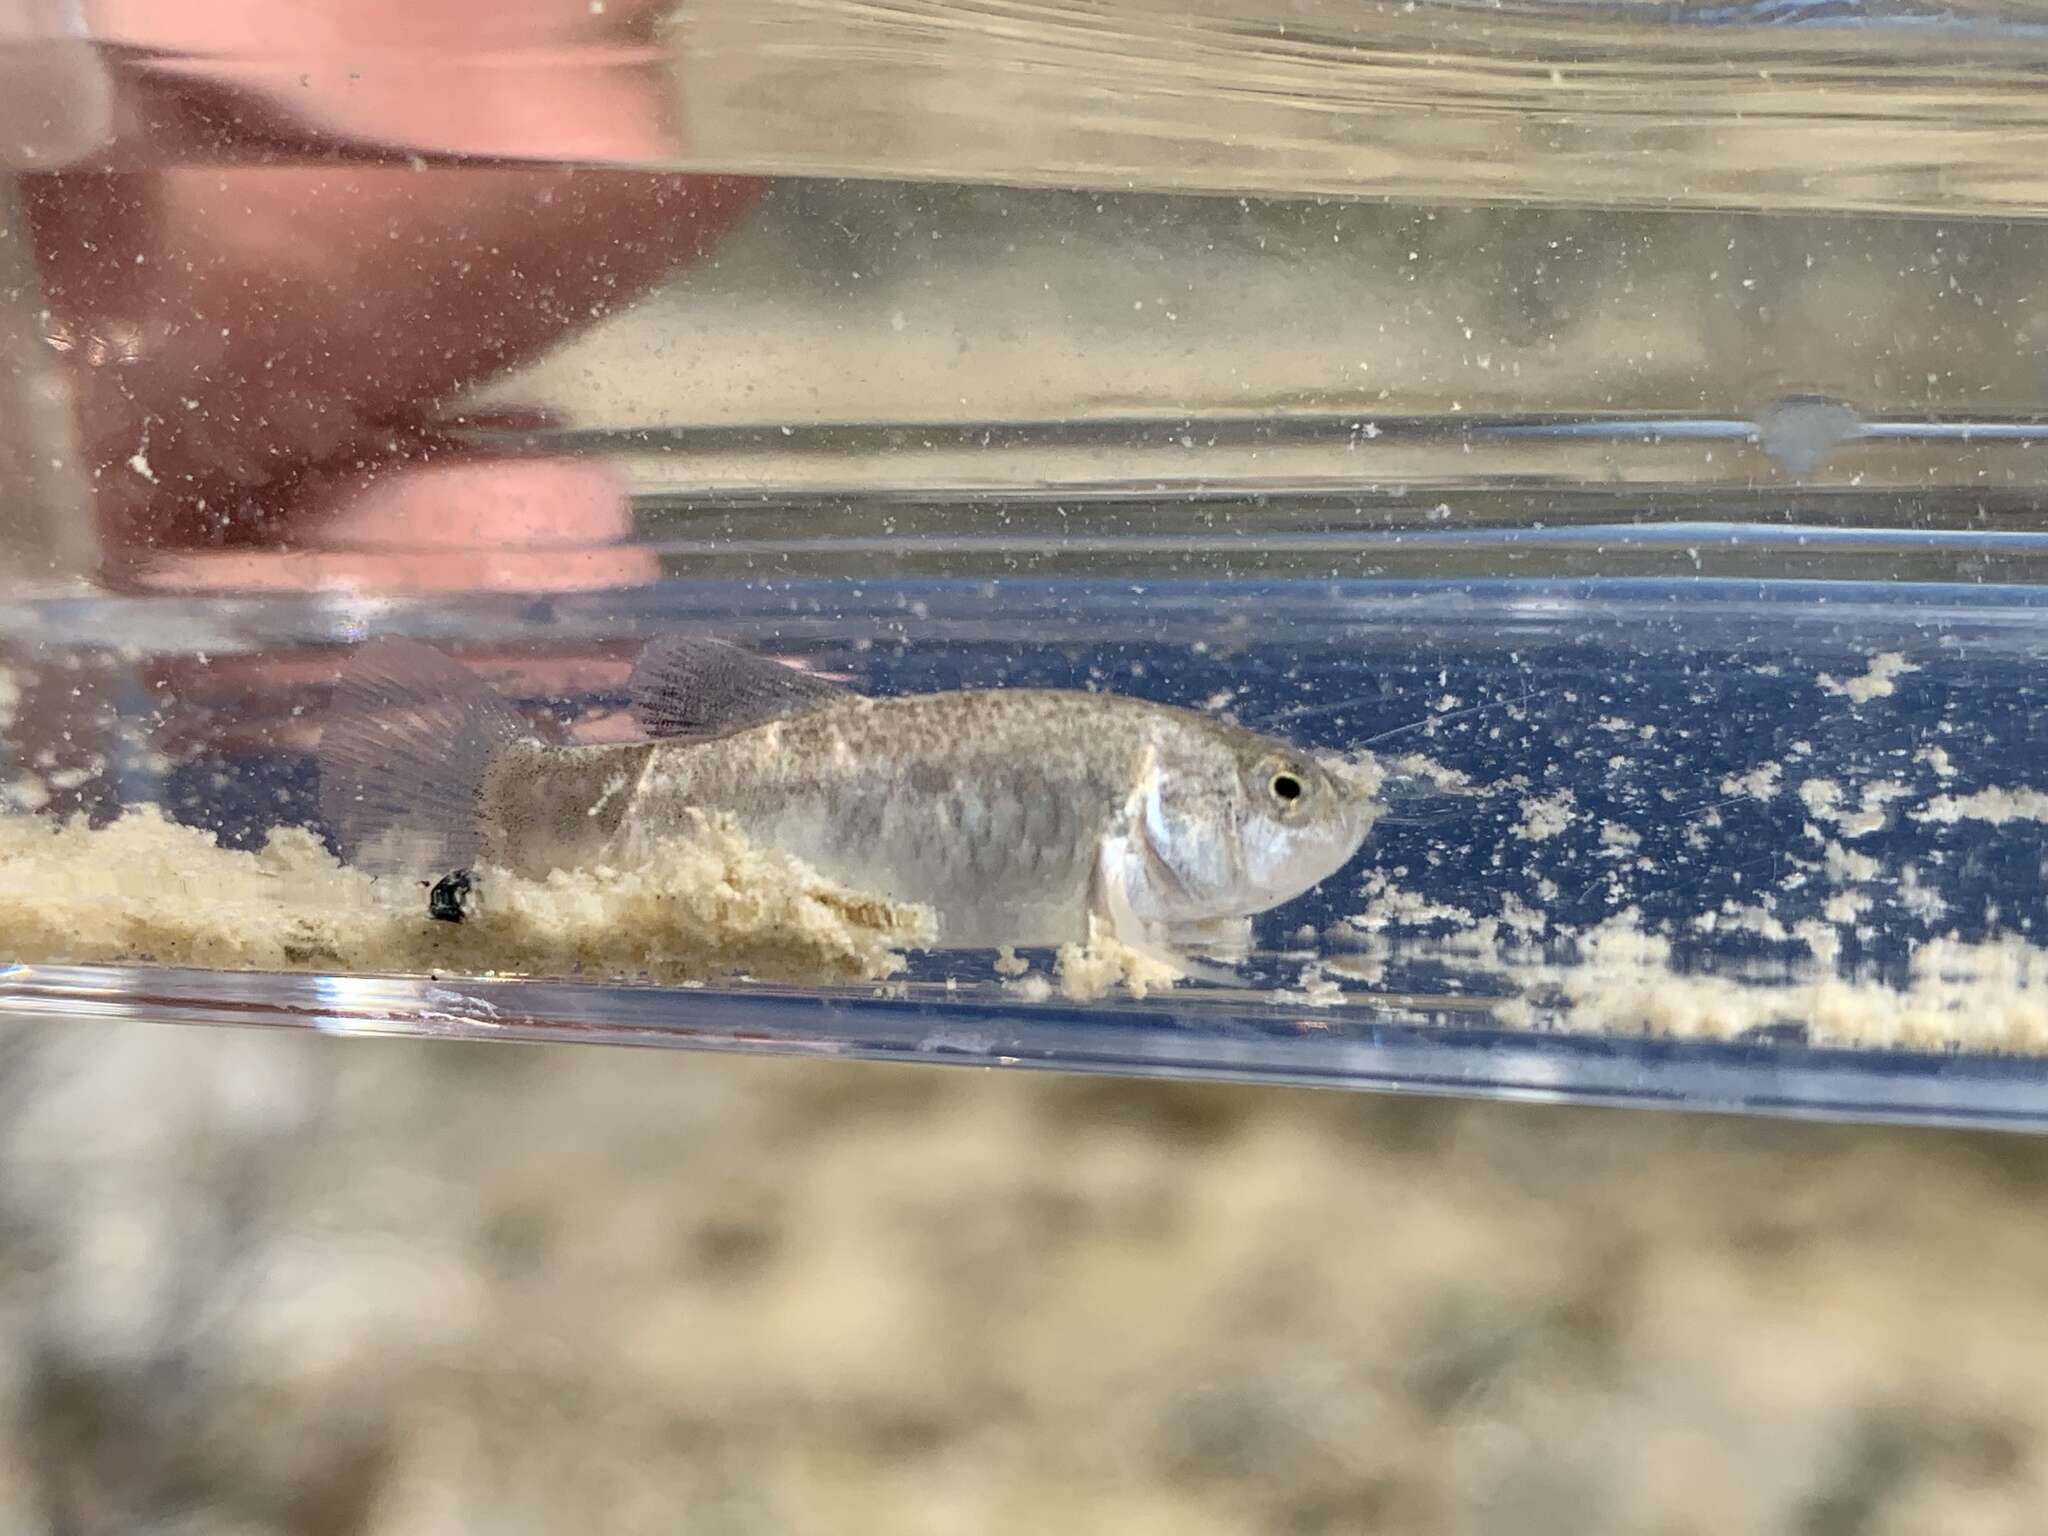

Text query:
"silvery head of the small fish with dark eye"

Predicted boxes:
[[1145, 731, 1380, 922]]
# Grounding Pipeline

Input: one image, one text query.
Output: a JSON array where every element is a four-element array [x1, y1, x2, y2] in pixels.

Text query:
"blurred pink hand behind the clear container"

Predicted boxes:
[[27, 0, 754, 590]]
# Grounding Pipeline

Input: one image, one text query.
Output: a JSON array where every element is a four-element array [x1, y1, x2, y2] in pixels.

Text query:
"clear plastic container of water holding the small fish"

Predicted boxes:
[[0, 0, 2048, 1126]]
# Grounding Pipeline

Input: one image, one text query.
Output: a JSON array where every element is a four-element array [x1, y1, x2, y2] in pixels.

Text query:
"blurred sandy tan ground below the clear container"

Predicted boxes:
[[0, 1026, 2048, 1536]]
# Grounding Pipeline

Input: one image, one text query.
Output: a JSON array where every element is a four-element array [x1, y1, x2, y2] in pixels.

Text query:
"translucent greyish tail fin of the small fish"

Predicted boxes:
[[317, 639, 532, 874]]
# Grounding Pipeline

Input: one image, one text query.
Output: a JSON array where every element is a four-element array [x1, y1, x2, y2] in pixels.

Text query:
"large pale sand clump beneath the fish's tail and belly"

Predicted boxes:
[[0, 807, 936, 983]]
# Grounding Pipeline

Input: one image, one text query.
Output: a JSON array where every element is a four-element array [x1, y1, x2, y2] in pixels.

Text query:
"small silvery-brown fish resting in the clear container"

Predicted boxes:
[[319, 637, 1380, 969]]
